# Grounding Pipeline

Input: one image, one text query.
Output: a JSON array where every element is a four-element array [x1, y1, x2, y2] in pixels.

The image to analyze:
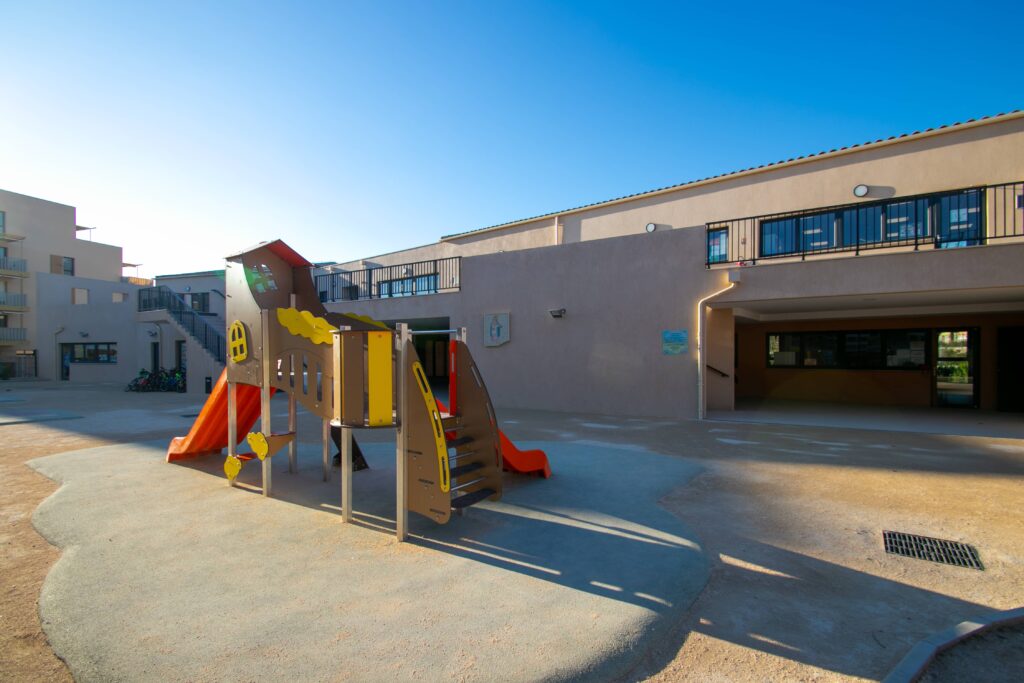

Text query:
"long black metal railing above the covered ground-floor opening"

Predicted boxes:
[[705, 182, 1024, 267]]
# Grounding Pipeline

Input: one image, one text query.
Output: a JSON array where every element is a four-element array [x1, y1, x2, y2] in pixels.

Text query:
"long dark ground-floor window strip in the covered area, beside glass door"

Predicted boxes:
[[767, 330, 929, 370]]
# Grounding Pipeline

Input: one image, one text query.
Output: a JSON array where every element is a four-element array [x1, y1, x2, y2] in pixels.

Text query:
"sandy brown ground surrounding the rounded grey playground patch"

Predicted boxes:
[[0, 384, 1024, 681]]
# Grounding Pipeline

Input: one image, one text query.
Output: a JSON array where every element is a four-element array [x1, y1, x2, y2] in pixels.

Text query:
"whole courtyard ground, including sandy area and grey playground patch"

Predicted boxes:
[[0, 384, 1024, 681]]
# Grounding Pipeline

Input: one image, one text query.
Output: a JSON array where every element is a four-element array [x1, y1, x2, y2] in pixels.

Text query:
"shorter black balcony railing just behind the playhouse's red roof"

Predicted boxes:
[[315, 256, 462, 302]]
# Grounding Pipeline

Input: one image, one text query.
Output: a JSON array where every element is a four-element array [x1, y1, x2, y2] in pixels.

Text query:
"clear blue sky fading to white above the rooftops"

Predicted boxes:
[[0, 0, 1024, 274]]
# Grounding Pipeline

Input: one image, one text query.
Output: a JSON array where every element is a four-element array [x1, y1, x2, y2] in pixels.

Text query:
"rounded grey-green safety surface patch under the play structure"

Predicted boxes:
[[31, 441, 708, 681]]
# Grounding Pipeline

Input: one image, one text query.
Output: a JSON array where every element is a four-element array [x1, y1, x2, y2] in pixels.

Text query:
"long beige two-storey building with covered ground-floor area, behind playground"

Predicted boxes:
[[316, 112, 1024, 418]]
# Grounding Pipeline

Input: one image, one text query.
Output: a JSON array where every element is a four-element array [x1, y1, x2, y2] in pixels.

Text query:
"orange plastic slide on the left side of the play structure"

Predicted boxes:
[[167, 370, 268, 463]]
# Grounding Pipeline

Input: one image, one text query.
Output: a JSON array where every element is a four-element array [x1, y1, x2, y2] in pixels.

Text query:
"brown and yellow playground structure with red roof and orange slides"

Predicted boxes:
[[167, 240, 551, 541]]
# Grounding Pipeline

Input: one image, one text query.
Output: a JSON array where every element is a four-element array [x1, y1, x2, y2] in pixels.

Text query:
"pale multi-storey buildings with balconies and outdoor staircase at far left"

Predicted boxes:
[[0, 190, 224, 391]]
